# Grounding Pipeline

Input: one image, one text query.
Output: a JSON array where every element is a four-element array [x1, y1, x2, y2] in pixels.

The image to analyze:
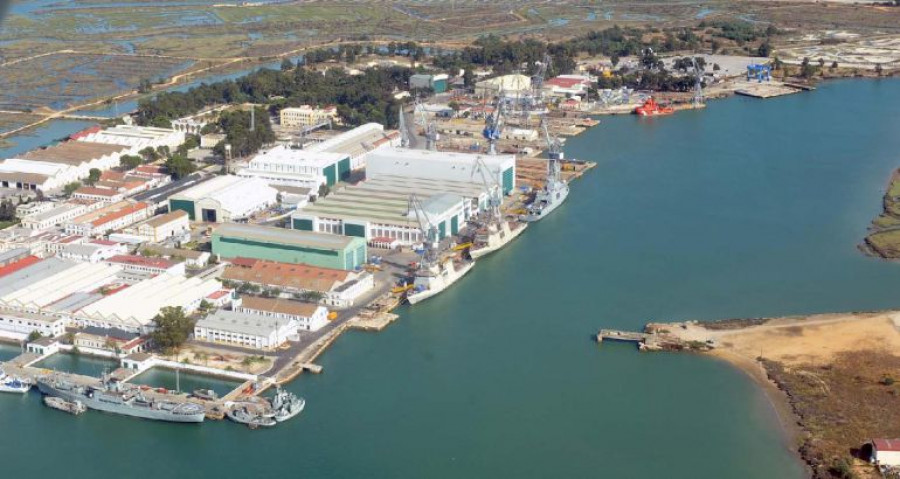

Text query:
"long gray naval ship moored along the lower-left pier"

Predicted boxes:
[[37, 376, 206, 423]]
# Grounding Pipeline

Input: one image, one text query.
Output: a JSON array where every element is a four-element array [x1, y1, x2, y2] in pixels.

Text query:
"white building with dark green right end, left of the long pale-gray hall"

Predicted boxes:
[[237, 145, 351, 191]]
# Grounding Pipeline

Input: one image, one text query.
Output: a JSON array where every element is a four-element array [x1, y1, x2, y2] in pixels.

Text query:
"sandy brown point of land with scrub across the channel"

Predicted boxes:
[[669, 311, 900, 478]]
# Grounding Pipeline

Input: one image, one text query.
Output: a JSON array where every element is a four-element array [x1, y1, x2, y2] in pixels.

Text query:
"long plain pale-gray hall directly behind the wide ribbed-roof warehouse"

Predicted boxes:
[[366, 148, 516, 195]]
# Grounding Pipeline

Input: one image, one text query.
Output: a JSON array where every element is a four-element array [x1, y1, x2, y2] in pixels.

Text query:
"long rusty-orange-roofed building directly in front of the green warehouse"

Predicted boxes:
[[221, 258, 375, 308]]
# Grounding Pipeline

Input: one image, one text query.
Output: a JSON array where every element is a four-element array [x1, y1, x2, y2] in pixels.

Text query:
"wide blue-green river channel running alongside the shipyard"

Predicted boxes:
[[0, 80, 900, 479]]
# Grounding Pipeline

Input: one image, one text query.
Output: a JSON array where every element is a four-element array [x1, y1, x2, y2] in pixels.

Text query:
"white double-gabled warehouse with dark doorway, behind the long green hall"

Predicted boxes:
[[169, 175, 278, 223]]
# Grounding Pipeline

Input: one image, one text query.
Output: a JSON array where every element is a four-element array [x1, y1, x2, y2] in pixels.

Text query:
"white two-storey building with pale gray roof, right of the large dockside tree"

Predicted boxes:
[[194, 309, 298, 350]]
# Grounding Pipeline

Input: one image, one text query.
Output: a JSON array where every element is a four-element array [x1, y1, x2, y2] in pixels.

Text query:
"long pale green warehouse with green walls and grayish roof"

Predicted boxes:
[[212, 223, 366, 270]]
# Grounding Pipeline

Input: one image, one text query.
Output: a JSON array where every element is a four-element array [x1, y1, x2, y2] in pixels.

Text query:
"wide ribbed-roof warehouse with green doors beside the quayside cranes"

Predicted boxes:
[[291, 175, 487, 245]]
